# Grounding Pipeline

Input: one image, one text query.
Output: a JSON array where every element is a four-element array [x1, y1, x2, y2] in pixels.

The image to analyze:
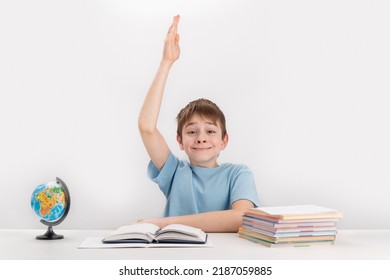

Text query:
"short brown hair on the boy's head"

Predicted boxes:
[[176, 98, 227, 138]]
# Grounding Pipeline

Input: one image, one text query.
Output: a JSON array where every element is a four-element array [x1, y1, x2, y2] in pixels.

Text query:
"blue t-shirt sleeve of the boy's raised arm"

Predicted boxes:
[[147, 153, 179, 197]]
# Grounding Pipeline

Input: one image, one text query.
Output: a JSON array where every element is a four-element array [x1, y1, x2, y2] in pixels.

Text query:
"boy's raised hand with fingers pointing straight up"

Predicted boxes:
[[163, 15, 180, 63]]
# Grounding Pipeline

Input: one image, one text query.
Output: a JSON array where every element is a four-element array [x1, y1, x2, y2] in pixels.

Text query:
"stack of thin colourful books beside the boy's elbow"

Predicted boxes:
[[238, 205, 342, 247]]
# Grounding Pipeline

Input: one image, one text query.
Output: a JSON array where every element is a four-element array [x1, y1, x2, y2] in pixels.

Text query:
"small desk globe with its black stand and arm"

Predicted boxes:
[[31, 178, 70, 240]]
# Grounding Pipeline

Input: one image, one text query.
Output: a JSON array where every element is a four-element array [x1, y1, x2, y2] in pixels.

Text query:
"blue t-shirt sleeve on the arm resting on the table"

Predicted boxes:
[[230, 166, 260, 207]]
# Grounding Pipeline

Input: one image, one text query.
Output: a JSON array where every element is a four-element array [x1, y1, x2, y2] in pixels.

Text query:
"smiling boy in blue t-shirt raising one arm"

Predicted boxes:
[[138, 16, 258, 232]]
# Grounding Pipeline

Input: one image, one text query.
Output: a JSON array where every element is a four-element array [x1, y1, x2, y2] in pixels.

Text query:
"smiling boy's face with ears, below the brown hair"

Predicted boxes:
[[177, 115, 228, 168]]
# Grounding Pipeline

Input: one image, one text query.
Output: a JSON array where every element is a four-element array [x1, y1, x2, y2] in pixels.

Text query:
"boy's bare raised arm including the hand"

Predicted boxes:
[[138, 16, 180, 170]]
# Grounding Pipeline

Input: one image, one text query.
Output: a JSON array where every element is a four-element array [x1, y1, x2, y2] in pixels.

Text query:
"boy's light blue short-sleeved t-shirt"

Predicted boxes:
[[148, 153, 259, 217]]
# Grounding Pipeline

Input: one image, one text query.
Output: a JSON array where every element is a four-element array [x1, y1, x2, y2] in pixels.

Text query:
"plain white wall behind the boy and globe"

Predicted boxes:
[[0, 0, 390, 229]]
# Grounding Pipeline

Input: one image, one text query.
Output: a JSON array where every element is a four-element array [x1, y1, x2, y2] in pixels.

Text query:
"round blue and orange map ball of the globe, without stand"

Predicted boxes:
[[31, 182, 67, 222]]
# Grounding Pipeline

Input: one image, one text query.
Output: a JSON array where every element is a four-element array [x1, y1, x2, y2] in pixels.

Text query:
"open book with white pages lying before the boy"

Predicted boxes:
[[102, 223, 207, 244]]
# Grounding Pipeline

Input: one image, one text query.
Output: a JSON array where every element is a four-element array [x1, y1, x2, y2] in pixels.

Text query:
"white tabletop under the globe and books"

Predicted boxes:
[[0, 229, 390, 260]]
